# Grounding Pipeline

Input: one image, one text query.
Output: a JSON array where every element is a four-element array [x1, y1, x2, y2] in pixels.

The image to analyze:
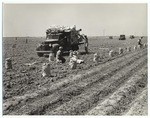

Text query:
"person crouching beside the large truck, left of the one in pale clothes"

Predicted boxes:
[[56, 47, 66, 63]]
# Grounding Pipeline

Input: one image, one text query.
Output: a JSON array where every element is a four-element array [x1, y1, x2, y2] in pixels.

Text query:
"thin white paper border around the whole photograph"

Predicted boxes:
[[0, 0, 150, 118]]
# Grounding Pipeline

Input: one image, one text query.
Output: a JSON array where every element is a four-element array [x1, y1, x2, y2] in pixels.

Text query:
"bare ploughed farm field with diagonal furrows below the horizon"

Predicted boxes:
[[3, 37, 148, 115]]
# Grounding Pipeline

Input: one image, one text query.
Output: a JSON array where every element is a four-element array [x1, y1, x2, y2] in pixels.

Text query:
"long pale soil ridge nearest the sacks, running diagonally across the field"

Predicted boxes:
[[3, 50, 145, 114]]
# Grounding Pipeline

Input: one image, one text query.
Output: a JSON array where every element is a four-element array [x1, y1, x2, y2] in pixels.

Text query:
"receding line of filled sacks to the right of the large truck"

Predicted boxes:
[[93, 44, 147, 62]]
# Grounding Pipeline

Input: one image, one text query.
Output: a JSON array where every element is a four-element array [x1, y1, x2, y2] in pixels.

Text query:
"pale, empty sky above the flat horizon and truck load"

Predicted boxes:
[[3, 3, 147, 37]]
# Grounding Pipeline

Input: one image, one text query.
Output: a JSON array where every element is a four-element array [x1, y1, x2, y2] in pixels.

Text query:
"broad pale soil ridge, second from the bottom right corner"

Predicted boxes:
[[85, 66, 147, 115]]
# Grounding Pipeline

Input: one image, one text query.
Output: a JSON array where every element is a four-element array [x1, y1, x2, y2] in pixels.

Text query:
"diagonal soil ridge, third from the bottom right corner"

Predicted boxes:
[[46, 54, 146, 115]]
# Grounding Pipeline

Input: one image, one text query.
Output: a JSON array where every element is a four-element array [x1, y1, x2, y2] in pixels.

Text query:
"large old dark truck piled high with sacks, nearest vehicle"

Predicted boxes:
[[36, 26, 88, 57]]
